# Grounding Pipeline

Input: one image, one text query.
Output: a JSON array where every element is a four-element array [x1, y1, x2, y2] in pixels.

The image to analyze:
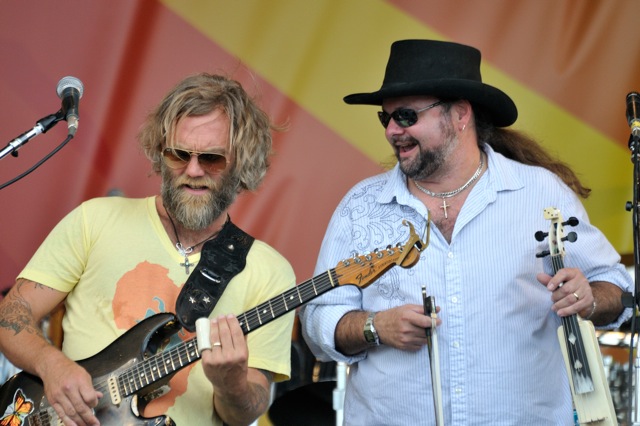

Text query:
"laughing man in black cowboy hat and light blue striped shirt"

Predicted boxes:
[[301, 40, 632, 425]]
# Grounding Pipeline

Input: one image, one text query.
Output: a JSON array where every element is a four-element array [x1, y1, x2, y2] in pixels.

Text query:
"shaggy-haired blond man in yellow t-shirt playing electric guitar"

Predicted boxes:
[[0, 74, 295, 425]]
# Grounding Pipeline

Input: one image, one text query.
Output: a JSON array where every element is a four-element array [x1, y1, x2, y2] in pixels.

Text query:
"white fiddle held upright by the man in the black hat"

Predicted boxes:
[[536, 207, 618, 426]]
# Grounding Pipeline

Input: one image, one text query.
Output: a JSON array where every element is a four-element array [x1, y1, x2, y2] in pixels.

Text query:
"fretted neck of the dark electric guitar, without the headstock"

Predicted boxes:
[[118, 268, 340, 395]]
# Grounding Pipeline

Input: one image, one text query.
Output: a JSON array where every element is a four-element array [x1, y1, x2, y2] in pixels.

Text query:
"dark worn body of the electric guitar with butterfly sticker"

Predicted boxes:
[[0, 313, 178, 426]]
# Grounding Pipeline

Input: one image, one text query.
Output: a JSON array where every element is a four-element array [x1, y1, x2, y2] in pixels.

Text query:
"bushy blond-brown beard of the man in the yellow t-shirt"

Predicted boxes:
[[161, 164, 240, 231]]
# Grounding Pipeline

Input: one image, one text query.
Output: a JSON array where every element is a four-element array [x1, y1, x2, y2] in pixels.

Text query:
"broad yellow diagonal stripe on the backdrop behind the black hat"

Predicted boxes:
[[162, 0, 633, 253]]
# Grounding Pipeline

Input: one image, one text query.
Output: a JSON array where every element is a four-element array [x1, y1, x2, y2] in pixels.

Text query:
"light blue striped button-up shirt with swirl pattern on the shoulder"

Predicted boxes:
[[301, 146, 632, 426]]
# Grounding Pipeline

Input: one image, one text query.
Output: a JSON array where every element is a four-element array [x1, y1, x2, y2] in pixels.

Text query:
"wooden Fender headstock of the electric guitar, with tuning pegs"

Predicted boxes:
[[335, 219, 430, 288]]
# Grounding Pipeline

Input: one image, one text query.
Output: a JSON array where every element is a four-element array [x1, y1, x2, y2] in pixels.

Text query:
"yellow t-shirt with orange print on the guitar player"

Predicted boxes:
[[20, 197, 295, 426]]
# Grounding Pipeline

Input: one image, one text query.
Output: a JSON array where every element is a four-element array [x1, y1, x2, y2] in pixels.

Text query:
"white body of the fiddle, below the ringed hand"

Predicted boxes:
[[558, 320, 618, 426]]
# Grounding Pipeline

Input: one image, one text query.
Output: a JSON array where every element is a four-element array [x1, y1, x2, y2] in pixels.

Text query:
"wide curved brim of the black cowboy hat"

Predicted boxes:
[[344, 79, 518, 127]]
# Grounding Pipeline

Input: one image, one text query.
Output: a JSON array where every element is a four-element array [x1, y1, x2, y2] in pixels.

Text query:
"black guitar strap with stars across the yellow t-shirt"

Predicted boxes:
[[176, 216, 254, 332]]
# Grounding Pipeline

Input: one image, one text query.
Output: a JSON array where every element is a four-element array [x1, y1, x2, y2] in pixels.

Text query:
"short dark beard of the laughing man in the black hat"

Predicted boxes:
[[393, 115, 457, 181]]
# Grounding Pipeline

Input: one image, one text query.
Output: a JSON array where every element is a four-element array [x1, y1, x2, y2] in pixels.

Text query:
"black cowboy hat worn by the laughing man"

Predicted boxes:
[[344, 40, 518, 127]]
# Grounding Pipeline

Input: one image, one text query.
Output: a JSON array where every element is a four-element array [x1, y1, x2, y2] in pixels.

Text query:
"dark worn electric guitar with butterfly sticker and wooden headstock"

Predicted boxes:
[[0, 221, 429, 426]]
